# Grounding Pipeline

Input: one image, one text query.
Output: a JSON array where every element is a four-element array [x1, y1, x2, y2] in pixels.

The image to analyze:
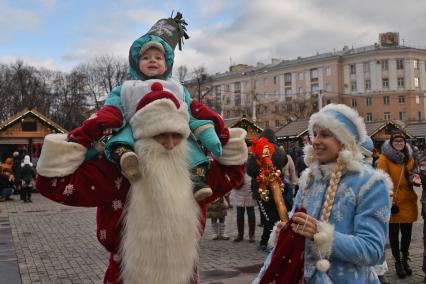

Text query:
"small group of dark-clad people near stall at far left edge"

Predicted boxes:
[[0, 151, 36, 202]]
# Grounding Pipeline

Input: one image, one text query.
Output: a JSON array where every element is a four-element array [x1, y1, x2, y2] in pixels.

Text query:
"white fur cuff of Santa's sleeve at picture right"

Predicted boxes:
[[214, 128, 248, 166]]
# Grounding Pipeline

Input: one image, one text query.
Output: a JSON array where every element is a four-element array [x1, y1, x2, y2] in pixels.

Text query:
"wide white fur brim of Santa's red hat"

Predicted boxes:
[[130, 99, 190, 140]]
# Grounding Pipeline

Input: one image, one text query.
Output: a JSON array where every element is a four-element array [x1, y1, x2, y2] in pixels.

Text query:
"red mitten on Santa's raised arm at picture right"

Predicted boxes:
[[190, 100, 229, 145]]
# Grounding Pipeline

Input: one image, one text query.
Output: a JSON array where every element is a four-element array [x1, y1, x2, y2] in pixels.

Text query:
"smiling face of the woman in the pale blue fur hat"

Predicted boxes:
[[312, 127, 343, 164]]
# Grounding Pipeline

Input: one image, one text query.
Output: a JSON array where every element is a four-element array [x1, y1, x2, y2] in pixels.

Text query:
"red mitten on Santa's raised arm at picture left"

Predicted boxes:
[[68, 106, 123, 148]]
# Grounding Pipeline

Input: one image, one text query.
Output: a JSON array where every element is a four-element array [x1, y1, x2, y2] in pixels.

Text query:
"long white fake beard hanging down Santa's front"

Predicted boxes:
[[120, 139, 200, 284]]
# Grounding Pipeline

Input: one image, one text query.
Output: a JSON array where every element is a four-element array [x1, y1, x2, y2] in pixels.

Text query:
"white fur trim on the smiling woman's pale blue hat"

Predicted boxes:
[[309, 104, 367, 145]]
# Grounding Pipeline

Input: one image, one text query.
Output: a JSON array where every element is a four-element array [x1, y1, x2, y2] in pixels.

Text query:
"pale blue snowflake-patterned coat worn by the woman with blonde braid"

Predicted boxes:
[[254, 162, 392, 284]]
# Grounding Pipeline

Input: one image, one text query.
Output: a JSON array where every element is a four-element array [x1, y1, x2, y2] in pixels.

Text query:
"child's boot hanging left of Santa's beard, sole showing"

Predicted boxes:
[[114, 146, 141, 183]]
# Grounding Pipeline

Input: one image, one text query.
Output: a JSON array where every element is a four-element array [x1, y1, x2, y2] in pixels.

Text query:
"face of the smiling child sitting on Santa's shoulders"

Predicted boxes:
[[139, 48, 166, 78]]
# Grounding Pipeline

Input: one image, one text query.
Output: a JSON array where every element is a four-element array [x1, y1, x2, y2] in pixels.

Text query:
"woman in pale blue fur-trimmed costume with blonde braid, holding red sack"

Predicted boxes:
[[253, 104, 391, 284]]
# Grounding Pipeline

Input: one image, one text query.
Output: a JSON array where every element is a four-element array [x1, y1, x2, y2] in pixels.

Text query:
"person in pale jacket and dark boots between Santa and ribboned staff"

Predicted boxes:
[[229, 173, 256, 243]]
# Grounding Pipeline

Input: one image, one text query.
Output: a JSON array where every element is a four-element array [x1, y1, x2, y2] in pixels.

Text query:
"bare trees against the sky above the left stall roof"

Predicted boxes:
[[0, 55, 129, 130]]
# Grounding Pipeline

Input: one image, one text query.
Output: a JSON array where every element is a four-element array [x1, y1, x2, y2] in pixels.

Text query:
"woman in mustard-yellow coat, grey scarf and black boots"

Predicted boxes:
[[377, 131, 418, 278]]
